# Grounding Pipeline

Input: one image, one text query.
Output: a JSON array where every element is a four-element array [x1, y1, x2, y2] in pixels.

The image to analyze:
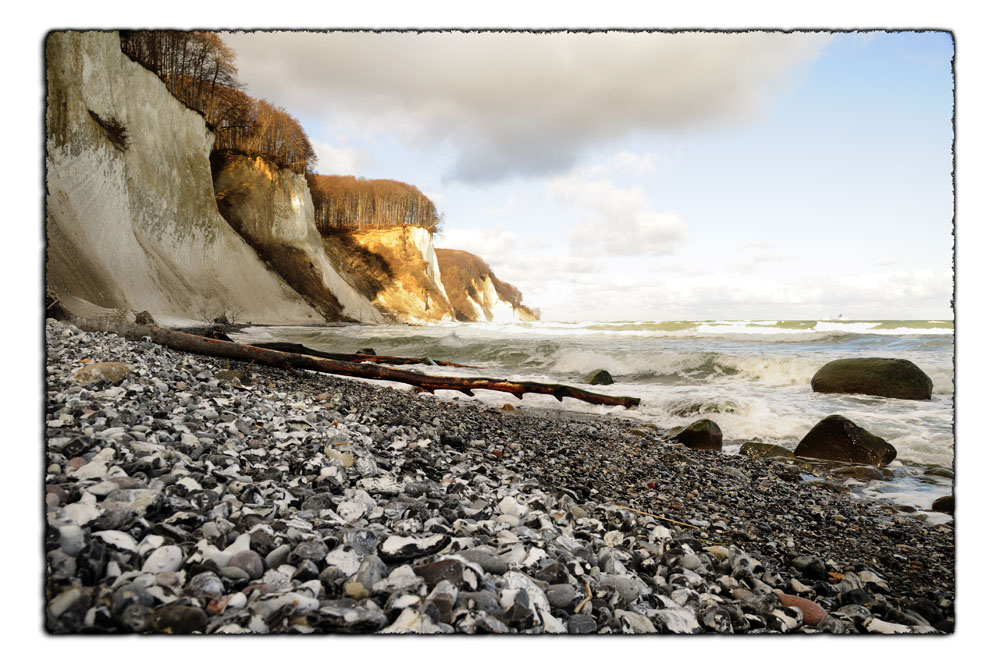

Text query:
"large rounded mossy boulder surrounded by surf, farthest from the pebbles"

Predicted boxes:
[[812, 357, 934, 400]]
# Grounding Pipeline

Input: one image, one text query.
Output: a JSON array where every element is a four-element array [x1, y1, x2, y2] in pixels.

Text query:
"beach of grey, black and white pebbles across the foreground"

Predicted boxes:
[[44, 319, 955, 634]]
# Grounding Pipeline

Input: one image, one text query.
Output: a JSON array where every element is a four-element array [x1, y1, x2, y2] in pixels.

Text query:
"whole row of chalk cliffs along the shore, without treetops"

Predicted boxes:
[[45, 32, 534, 324]]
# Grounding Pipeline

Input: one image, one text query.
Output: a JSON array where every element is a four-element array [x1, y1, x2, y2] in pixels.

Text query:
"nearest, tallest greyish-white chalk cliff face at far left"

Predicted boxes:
[[46, 32, 323, 323]]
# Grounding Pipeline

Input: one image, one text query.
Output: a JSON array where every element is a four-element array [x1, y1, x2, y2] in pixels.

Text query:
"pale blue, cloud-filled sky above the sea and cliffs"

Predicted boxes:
[[227, 32, 953, 320]]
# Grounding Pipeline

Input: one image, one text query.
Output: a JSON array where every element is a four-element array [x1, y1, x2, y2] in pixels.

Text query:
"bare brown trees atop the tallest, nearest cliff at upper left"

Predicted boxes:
[[119, 30, 316, 173]]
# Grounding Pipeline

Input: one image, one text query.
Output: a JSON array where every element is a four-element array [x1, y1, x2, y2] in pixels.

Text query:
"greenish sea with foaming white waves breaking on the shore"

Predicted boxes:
[[237, 319, 955, 522]]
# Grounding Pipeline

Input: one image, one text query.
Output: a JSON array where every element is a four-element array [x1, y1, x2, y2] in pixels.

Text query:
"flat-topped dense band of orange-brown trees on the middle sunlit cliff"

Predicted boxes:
[[306, 173, 441, 234]]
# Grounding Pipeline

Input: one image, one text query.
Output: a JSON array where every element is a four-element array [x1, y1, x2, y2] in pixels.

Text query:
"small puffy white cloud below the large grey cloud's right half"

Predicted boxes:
[[548, 172, 684, 256]]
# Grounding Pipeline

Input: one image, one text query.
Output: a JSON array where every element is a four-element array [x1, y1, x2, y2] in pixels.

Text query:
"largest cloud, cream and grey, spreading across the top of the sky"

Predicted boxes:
[[224, 32, 831, 182]]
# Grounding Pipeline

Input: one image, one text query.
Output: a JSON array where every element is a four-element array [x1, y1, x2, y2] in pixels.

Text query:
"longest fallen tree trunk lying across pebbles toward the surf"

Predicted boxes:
[[70, 318, 639, 408]]
